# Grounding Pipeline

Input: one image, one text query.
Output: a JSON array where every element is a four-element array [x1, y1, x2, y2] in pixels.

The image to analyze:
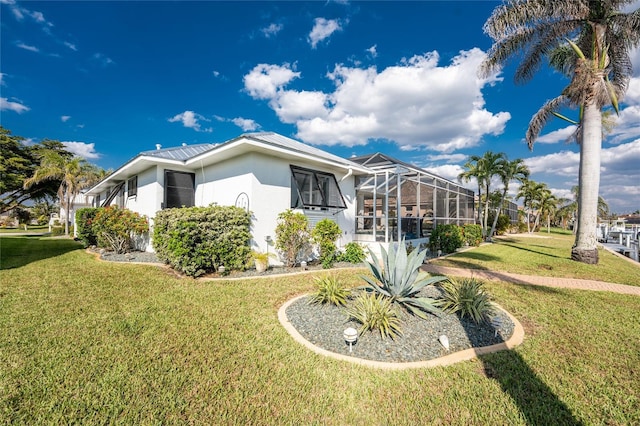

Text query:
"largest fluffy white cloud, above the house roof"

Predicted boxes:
[[244, 49, 511, 152]]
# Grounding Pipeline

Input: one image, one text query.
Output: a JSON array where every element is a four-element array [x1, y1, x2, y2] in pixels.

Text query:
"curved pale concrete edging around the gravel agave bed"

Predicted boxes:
[[278, 293, 524, 370]]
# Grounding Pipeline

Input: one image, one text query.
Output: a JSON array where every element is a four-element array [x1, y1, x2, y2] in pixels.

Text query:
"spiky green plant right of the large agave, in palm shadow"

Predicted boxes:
[[436, 278, 496, 323]]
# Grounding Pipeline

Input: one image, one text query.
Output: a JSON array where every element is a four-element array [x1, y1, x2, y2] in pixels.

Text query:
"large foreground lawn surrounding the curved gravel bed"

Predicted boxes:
[[0, 237, 640, 425]]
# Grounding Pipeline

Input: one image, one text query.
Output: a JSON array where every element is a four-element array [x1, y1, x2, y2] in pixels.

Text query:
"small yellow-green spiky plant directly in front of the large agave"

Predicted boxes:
[[347, 292, 402, 339]]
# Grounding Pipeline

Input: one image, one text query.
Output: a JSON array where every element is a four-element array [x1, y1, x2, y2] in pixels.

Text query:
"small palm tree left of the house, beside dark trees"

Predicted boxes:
[[24, 150, 100, 236]]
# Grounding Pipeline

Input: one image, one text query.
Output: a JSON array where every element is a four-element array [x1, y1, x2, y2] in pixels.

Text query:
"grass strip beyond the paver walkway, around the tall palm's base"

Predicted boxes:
[[432, 230, 640, 286]]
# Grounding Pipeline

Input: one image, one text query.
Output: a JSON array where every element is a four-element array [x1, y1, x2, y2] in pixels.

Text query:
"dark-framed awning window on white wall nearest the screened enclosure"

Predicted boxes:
[[291, 166, 346, 209]]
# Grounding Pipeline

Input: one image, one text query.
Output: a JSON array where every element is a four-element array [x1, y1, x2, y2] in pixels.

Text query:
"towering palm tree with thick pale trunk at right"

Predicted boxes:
[[481, 0, 640, 263]]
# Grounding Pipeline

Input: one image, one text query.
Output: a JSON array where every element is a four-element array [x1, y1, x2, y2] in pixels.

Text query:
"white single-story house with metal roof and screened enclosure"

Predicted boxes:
[[86, 132, 475, 255]]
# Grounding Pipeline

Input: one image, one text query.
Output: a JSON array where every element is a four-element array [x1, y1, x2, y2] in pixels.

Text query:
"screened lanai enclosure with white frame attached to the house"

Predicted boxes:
[[350, 153, 475, 247]]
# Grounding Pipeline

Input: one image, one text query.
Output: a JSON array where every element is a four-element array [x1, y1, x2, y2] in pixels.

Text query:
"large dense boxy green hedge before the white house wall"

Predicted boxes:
[[153, 205, 251, 277]]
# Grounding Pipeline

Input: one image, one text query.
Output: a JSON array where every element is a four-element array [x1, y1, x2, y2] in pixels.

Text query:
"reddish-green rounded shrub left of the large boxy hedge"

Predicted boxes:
[[91, 206, 149, 253]]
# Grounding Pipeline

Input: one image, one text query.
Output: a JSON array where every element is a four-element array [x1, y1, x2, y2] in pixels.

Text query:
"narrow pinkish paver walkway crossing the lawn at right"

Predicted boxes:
[[422, 263, 640, 296]]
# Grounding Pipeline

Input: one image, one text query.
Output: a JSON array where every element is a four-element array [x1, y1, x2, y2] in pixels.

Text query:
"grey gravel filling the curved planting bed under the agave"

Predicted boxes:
[[286, 287, 514, 362]]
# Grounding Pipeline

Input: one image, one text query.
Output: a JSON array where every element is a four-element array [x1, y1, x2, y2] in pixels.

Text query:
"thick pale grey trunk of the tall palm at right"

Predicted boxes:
[[571, 102, 602, 264]]
